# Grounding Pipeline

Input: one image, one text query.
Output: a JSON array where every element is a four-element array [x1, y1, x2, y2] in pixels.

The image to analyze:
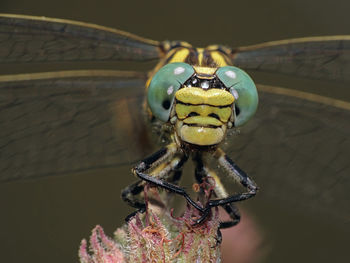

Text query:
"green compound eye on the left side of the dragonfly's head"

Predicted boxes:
[[147, 62, 194, 122]]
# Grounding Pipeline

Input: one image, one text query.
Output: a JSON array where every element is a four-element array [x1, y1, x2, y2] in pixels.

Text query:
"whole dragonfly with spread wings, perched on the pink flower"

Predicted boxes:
[[0, 14, 350, 243]]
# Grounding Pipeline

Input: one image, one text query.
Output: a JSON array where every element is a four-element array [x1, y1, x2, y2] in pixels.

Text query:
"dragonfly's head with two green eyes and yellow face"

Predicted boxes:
[[147, 62, 258, 146]]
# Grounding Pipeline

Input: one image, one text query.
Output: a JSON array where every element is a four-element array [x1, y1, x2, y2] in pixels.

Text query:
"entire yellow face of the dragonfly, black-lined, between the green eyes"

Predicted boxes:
[[175, 87, 234, 146]]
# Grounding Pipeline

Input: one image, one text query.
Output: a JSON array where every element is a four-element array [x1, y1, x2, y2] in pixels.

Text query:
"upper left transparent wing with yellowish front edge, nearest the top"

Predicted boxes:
[[0, 14, 161, 62]]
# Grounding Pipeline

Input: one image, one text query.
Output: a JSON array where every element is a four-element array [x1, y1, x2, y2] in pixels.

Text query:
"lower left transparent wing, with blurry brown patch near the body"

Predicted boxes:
[[0, 70, 152, 181]]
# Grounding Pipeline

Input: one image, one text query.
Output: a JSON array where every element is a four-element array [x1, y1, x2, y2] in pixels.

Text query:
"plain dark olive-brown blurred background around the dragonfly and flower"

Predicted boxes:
[[0, 0, 350, 263]]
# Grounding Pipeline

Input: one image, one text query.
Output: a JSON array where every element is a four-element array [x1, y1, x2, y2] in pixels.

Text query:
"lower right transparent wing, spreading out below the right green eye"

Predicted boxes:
[[225, 85, 350, 222]]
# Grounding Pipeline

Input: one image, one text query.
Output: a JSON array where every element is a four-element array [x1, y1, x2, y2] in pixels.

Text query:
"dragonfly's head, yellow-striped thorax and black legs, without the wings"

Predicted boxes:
[[122, 42, 258, 227]]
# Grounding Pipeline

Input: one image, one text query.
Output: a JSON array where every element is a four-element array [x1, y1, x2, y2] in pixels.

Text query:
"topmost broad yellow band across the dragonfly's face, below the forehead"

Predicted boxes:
[[175, 87, 235, 106]]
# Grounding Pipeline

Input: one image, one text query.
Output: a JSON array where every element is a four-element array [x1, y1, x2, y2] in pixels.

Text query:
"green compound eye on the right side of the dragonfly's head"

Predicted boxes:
[[216, 66, 258, 127]]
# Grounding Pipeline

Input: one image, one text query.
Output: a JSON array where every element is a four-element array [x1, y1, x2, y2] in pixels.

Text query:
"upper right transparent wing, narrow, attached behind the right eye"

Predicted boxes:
[[231, 36, 350, 81]]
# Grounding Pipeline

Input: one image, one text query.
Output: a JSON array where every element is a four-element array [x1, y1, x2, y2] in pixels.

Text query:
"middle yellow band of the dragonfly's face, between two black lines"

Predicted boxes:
[[175, 103, 232, 125]]
